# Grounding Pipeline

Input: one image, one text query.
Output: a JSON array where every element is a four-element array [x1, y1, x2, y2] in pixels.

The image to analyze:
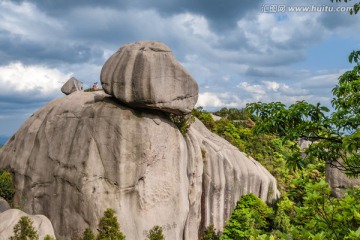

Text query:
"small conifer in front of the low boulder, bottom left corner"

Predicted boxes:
[[10, 216, 39, 240]]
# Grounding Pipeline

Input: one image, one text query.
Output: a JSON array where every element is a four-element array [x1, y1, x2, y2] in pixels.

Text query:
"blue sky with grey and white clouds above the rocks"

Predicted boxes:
[[0, 0, 360, 136]]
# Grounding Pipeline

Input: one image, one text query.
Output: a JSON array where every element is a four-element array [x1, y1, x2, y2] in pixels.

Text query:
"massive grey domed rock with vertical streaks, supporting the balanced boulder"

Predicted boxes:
[[0, 91, 279, 240]]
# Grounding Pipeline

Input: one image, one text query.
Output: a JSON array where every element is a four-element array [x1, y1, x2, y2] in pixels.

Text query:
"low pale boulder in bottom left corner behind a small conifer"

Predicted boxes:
[[0, 209, 55, 240]]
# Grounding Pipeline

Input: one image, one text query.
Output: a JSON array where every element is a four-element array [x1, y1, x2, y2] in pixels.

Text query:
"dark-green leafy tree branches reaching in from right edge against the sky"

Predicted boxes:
[[247, 53, 360, 177]]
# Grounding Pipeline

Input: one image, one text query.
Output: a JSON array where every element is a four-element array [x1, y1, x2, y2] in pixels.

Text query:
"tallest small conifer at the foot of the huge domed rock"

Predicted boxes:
[[96, 208, 125, 240]]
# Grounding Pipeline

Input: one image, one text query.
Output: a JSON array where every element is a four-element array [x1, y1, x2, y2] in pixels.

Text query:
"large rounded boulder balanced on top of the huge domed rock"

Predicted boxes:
[[100, 41, 199, 114]]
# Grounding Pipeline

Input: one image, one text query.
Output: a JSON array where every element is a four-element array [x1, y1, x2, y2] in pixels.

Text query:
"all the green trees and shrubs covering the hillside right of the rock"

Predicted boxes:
[[193, 48, 360, 240]]
